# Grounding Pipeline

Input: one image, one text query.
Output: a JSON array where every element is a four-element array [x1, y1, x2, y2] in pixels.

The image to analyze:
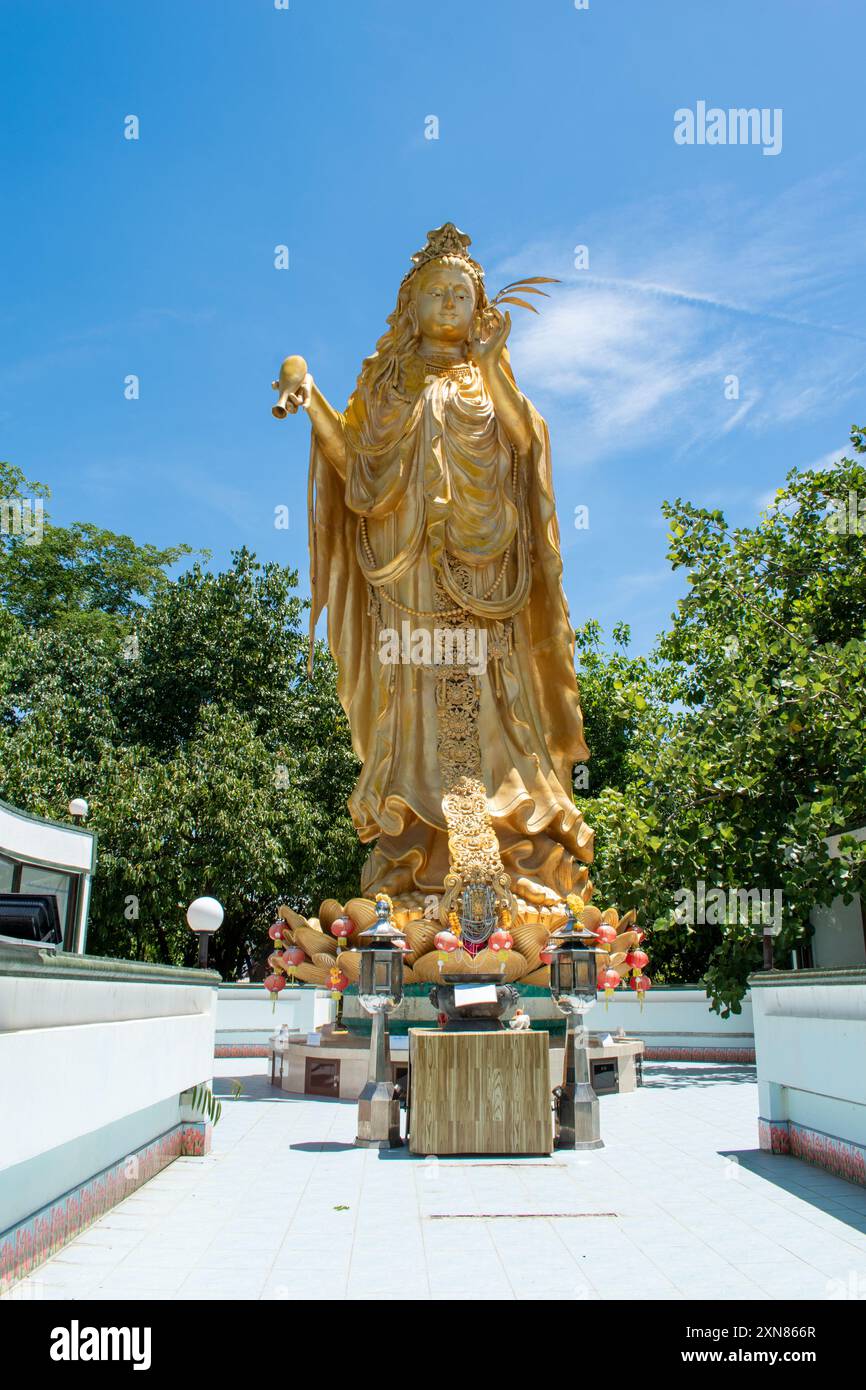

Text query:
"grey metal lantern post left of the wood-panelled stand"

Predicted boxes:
[[354, 898, 406, 1148]]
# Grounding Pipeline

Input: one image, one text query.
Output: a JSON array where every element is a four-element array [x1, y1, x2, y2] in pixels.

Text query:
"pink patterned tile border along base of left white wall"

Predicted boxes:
[[0, 1120, 211, 1293]]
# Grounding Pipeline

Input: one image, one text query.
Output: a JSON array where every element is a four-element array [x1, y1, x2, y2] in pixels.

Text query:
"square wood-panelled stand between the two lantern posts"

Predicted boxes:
[[409, 1029, 553, 1154]]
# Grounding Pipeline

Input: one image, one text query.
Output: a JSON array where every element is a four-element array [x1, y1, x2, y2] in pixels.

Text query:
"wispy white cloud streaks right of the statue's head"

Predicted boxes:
[[491, 175, 866, 463]]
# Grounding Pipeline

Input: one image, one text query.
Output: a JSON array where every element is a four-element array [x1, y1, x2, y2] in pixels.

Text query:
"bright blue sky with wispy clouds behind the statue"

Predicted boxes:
[[0, 0, 866, 649]]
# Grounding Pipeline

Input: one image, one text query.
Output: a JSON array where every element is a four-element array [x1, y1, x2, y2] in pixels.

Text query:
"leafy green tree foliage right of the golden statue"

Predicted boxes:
[[578, 430, 866, 1012]]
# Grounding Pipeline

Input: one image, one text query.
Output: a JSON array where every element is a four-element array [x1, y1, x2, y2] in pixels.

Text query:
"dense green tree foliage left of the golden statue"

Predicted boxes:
[[0, 470, 364, 977]]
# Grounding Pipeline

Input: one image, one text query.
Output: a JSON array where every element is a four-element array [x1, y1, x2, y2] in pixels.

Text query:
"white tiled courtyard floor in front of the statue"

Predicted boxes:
[[6, 1061, 866, 1302]]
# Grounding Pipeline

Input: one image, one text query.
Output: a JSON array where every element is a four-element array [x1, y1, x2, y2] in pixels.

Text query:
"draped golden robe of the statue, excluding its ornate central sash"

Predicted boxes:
[[310, 355, 592, 897]]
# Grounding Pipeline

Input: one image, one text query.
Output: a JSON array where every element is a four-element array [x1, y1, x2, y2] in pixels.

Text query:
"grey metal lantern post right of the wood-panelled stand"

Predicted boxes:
[[548, 909, 605, 1148]]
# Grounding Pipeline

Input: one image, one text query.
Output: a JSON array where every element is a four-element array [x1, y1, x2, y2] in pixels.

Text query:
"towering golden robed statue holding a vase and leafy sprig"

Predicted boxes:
[[274, 222, 592, 904]]
